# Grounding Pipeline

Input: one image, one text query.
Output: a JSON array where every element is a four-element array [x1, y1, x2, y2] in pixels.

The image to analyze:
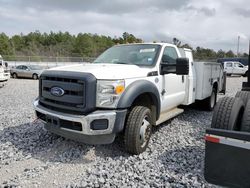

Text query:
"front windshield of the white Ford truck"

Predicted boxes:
[[93, 44, 160, 66]]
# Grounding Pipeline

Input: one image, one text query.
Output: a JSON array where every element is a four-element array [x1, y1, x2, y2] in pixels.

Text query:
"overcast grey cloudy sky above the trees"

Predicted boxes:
[[0, 0, 250, 52]]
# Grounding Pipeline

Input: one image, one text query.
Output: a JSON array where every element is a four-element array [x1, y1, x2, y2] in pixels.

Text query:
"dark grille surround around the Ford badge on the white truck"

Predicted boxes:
[[39, 71, 96, 114]]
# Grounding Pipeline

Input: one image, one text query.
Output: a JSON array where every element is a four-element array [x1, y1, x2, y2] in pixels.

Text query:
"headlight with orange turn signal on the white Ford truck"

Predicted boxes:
[[96, 80, 125, 108]]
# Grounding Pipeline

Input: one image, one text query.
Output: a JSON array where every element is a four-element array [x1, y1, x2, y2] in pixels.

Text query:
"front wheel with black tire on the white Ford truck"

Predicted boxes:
[[124, 106, 152, 154]]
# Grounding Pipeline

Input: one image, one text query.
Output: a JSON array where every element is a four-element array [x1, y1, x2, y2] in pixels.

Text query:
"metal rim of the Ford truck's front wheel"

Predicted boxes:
[[140, 116, 151, 148]]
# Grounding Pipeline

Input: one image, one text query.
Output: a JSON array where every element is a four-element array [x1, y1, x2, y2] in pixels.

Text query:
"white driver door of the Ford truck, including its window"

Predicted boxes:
[[162, 46, 186, 111]]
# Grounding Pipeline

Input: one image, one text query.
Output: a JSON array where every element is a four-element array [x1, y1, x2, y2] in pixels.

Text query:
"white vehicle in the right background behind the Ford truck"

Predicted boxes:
[[224, 61, 248, 76]]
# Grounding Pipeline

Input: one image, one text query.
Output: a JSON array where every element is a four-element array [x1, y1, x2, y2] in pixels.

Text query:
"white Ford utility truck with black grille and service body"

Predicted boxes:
[[34, 43, 225, 154]]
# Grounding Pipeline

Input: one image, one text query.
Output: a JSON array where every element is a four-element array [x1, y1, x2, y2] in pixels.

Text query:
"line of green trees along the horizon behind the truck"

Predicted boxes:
[[0, 31, 247, 60]]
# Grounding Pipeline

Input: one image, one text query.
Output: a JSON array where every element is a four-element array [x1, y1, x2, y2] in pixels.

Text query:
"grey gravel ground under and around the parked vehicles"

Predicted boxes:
[[0, 77, 245, 187]]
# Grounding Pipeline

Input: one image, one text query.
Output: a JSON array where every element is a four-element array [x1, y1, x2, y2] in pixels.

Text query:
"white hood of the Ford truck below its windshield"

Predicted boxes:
[[49, 63, 152, 80]]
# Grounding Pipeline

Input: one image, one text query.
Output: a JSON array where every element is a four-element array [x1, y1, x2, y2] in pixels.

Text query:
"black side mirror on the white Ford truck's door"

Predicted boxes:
[[160, 58, 189, 75]]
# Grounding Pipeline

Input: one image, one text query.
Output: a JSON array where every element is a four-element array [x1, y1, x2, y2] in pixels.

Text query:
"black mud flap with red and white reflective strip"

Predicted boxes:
[[204, 129, 250, 187]]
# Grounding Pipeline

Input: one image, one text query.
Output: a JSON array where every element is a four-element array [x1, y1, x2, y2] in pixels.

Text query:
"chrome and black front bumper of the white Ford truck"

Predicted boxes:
[[34, 100, 127, 144]]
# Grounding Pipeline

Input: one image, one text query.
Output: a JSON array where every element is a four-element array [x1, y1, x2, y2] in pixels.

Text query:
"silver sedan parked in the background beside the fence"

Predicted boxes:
[[10, 65, 44, 80]]
